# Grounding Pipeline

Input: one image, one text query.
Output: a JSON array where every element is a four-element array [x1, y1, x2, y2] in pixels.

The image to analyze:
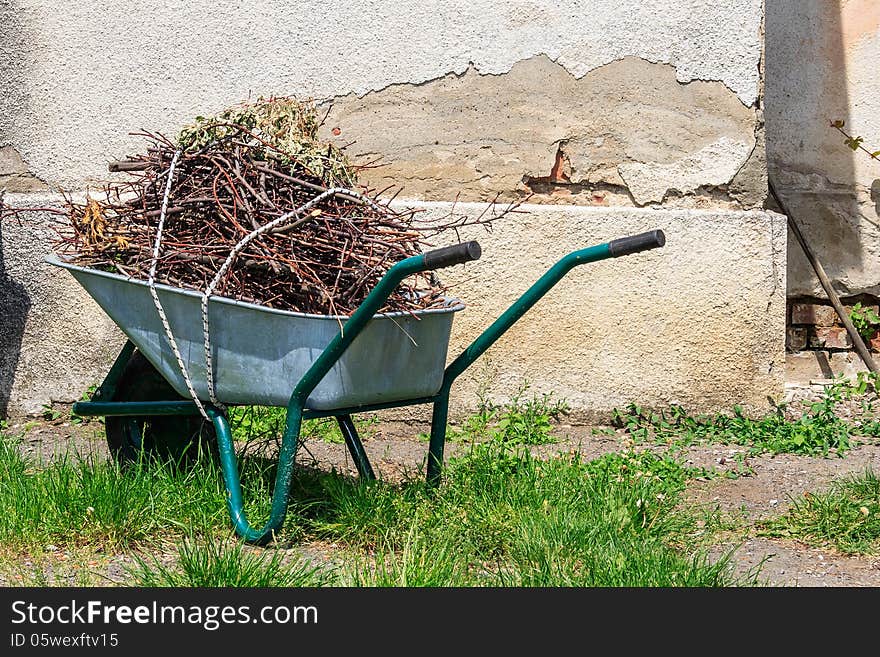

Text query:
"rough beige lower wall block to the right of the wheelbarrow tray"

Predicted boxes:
[[417, 204, 786, 420]]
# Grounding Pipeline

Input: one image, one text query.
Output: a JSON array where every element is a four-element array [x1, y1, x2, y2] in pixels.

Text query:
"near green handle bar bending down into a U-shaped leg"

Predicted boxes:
[[212, 242, 480, 543]]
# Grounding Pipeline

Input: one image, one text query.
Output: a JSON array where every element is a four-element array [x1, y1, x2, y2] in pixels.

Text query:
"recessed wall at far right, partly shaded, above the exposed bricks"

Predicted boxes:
[[764, 0, 880, 298]]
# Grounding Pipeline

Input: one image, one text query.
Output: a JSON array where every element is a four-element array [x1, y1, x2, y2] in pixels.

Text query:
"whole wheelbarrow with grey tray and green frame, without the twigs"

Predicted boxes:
[[47, 230, 666, 543]]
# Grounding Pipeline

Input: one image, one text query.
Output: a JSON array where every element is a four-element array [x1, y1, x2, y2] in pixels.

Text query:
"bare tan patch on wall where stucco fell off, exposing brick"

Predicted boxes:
[[324, 55, 767, 207]]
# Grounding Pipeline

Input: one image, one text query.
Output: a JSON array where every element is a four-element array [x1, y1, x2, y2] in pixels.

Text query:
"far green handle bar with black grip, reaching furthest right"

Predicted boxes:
[[427, 230, 666, 484]]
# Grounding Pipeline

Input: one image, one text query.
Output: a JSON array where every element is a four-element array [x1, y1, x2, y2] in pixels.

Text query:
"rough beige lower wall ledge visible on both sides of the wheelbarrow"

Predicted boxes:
[[0, 195, 786, 420]]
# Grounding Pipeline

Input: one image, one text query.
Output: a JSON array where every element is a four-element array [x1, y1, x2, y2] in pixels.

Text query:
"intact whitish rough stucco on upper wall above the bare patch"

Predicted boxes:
[[0, 0, 763, 187]]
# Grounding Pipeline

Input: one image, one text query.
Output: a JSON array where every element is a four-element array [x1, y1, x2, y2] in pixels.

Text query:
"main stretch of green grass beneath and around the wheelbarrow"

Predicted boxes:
[[0, 386, 812, 587]]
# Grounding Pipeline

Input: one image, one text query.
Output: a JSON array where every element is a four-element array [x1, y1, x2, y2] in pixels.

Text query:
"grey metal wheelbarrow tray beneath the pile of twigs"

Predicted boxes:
[[47, 256, 464, 410]]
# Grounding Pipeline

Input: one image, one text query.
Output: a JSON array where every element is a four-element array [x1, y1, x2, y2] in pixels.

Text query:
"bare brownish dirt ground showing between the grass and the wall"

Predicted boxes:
[[0, 382, 880, 587]]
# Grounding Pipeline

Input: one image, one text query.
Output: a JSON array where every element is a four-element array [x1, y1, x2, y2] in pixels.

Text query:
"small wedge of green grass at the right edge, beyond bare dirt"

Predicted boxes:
[[761, 469, 880, 555]]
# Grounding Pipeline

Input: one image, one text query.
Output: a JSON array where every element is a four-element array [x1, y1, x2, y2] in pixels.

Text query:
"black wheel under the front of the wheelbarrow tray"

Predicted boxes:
[[104, 351, 219, 467]]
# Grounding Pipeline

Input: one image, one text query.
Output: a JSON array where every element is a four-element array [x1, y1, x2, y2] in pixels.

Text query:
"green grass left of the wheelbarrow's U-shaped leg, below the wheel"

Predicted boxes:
[[0, 434, 271, 550]]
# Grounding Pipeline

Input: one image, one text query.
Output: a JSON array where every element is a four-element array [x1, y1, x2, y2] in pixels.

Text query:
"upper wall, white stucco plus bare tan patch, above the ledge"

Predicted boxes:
[[0, 0, 763, 204]]
